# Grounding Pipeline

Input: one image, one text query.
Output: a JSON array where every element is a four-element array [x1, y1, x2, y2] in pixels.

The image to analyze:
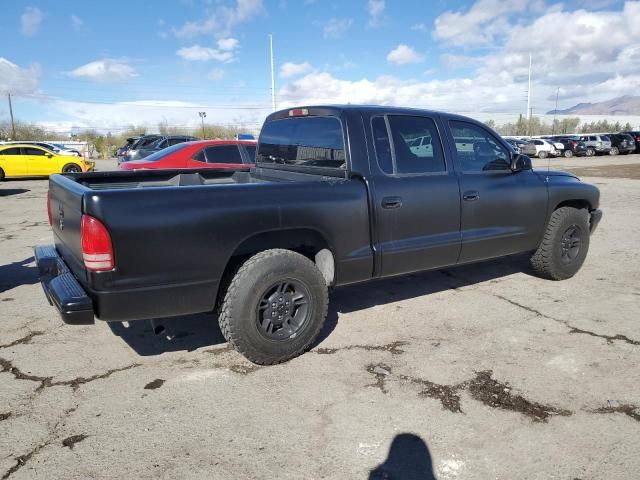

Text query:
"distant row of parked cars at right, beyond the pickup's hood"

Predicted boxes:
[[505, 132, 640, 158]]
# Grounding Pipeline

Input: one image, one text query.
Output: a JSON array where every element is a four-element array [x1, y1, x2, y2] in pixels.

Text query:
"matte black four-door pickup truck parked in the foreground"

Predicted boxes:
[[36, 105, 602, 364]]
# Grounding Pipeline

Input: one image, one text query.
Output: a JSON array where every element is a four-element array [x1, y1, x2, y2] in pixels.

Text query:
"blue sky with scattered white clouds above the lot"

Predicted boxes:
[[0, 0, 640, 130]]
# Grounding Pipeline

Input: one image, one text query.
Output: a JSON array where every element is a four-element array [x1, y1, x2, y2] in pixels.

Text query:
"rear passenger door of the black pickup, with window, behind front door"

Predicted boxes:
[[370, 114, 460, 276]]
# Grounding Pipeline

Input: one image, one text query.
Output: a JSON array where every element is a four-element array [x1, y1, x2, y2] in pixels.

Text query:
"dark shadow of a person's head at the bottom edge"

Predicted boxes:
[[369, 433, 436, 480]]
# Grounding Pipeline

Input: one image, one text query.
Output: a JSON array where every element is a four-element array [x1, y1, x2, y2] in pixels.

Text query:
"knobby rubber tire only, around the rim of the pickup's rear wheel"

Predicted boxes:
[[218, 249, 329, 365]]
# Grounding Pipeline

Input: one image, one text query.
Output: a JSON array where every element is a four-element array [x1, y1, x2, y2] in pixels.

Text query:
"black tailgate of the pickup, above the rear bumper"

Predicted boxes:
[[49, 175, 89, 286]]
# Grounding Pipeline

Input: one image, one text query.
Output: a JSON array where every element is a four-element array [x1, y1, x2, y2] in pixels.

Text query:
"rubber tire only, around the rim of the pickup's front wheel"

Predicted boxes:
[[531, 207, 589, 280]]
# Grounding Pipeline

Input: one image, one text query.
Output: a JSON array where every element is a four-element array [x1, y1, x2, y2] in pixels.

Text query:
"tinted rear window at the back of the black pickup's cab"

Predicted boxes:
[[256, 117, 346, 169]]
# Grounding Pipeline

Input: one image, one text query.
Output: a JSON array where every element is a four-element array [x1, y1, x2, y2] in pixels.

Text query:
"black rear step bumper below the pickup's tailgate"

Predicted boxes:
[[35, 245, 95, 325]]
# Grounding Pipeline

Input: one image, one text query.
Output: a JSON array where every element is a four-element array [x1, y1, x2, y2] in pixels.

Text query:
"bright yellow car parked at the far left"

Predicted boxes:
[[0, 143, 95, 181]]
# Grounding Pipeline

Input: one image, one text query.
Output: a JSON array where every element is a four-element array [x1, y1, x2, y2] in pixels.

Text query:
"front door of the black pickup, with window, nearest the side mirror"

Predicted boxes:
[[448, 120, 548, 263]]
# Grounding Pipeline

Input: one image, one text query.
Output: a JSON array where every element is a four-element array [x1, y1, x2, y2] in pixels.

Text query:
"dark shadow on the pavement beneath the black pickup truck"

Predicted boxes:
[[108, 256, 530, 356]]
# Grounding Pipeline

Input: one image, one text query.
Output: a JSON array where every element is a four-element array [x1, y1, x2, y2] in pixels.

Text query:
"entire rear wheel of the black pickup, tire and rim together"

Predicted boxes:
[[218, 249, 329, 365]]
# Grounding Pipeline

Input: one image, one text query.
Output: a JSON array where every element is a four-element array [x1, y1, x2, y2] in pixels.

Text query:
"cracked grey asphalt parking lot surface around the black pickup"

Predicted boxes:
[[0, 155, 640, 480]]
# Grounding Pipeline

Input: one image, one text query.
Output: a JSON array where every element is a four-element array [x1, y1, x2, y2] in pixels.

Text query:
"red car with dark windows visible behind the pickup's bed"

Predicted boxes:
[[119, 140, 256, 170]]
